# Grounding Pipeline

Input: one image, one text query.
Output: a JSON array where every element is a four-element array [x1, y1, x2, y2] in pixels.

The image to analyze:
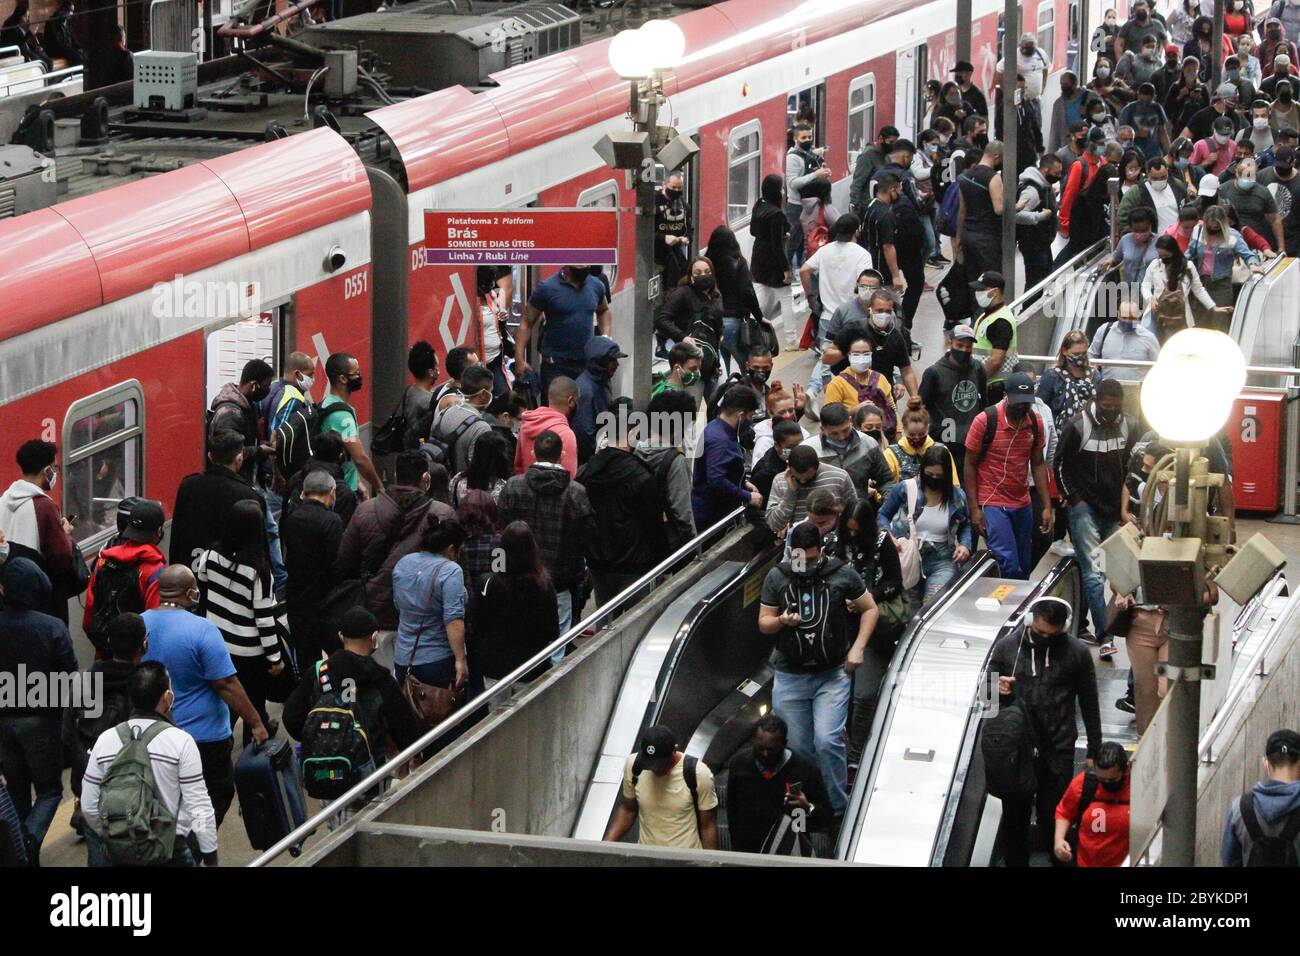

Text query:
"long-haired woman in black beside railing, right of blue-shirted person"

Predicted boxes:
[[469, 522, 560, 687]]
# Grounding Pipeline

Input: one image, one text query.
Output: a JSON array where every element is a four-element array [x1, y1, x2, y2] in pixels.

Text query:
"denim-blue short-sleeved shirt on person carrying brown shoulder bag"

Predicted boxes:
[[393, 551, 465, 666]]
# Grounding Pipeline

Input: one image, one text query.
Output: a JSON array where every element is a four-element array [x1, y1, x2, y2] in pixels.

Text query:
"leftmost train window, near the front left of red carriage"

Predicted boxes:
[[62, 380, 144, 544]]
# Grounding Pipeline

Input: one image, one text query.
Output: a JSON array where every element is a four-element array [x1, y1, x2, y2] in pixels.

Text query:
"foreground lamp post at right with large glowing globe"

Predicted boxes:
[[1141, 329, 1245, 866]]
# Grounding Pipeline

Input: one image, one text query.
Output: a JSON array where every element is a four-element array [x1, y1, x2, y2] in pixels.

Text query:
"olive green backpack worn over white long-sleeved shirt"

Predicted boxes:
[[99, 721, 176, 866]]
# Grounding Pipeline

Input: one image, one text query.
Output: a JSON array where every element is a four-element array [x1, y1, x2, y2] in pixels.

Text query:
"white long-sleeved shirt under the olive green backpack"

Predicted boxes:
[[82, 717, 217, 853]]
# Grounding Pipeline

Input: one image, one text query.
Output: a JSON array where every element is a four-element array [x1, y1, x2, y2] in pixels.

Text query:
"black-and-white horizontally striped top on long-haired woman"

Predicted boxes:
[[196, 550, 286, 663]]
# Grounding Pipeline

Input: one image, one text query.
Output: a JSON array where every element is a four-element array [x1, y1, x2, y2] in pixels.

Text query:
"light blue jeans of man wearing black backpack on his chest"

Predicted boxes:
[[772, 665, 853, 817]]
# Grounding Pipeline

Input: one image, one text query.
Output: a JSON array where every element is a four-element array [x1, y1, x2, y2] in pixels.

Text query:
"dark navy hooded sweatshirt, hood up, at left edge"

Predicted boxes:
[[0, 558, 78, 718]]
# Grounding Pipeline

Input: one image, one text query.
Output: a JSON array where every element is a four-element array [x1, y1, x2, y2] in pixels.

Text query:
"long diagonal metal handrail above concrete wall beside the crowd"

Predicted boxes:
[[248, 507, 745, 866]]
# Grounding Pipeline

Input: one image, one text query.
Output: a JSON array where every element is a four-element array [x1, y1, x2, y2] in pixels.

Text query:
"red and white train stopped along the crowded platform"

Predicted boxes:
[[0, 0, 1097, 553]]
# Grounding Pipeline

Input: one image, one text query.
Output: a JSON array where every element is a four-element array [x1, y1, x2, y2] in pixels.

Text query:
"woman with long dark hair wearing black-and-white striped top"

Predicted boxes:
[[195, 501, 289, 744]]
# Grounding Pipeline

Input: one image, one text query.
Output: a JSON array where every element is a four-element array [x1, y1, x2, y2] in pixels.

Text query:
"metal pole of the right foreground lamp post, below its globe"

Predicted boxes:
[[1160, 446, 1205, 866]]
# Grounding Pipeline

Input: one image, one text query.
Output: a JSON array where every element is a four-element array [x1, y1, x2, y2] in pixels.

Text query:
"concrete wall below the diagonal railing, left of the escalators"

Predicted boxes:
[[300, 528, 748, 865]]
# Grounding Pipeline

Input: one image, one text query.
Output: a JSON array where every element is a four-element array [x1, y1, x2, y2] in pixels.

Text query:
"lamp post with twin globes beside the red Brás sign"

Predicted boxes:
[[595, 20, 698, 408]]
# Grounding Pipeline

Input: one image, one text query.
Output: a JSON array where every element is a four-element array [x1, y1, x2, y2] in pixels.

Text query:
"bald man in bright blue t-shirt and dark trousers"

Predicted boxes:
[[140, 564, 267, 827]]
